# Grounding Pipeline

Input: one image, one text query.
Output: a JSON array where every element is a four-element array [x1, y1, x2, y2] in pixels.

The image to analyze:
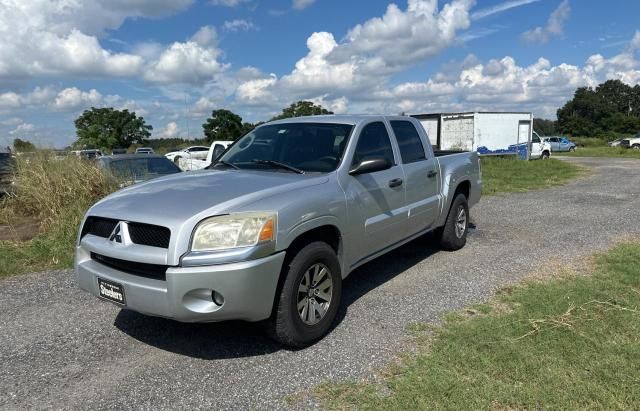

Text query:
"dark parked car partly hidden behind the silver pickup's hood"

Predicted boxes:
[[98, 154, 182, 186]]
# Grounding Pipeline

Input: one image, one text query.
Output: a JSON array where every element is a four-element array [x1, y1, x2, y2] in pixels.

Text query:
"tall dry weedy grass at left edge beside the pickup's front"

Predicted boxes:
[[0, 152, 116, 278]]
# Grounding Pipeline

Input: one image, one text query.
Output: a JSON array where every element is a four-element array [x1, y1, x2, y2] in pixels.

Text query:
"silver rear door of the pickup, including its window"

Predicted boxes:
[[390, 120, 440, 236]]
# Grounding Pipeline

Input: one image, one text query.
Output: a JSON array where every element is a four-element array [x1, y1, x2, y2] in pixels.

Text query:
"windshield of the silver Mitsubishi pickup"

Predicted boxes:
[[219, 123, 353, 173]]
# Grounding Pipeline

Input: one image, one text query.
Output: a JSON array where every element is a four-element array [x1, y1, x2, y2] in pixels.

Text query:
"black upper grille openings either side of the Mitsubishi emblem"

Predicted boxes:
[[82, 216, 171, 248]]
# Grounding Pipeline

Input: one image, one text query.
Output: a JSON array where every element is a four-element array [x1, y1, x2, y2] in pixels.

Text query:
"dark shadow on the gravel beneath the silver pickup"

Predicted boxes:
[[114, 235, 438, 360]]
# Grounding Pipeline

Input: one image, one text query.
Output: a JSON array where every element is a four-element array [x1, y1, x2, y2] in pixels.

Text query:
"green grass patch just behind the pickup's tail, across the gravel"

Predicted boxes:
[[482, 157, 584, 195]]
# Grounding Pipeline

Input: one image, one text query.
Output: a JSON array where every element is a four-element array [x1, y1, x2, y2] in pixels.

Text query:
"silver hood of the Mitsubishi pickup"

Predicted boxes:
[[88, 170, 328, 230]]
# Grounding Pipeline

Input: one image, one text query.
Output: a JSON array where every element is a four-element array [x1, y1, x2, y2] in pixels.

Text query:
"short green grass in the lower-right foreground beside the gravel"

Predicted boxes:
[[314, 243, 640, 410]]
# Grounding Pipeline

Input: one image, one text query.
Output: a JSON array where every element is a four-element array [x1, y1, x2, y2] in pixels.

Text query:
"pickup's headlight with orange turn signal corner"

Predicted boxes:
[[191, 213, 276, 251]]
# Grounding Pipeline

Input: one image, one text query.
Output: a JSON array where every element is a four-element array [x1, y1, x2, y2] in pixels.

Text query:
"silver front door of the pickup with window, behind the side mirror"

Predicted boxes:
[[344, 121, 407, 262]]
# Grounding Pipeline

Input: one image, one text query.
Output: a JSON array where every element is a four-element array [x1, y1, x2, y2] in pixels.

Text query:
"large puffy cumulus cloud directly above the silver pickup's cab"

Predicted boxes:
[[236, 0, 474, 108]]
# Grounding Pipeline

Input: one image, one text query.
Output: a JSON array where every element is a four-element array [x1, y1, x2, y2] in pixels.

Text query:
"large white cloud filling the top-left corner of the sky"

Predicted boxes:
[[0, 0, 193, 79]]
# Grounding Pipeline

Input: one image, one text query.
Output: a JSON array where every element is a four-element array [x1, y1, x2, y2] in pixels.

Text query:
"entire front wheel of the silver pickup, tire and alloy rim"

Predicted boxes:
[[268, 242, 342, 347]]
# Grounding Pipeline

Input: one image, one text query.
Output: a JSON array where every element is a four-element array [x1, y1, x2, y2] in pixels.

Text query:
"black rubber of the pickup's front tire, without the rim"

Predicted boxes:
[[267, 241, 342, 347]]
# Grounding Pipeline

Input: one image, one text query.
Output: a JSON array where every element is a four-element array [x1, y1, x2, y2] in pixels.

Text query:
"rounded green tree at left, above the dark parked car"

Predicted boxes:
[[74, 107, 153, 149]]
